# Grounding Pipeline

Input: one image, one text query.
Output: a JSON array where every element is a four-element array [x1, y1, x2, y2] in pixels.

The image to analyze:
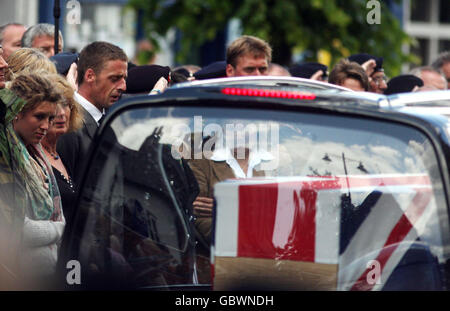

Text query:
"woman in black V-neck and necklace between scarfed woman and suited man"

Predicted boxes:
[[41, 74, 82, 221]]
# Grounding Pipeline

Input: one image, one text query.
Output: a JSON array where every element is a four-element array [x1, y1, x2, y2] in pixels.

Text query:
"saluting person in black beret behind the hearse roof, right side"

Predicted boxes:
[[348, 53, 387, 94]]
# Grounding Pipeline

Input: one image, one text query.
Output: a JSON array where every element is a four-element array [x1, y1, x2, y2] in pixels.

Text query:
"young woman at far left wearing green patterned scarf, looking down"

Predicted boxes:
[[0, 74, 65, 287]]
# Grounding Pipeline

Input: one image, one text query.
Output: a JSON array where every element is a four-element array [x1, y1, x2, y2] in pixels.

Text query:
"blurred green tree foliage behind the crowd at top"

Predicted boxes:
[[129, 0, 416, 75]]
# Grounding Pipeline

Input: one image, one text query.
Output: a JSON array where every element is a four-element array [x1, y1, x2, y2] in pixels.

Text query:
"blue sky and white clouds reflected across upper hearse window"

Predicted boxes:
[[112, 109, 430, 176]]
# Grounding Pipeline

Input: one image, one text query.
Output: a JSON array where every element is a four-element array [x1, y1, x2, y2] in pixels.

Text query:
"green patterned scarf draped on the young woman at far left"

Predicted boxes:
[[0, 89, 62, 278]]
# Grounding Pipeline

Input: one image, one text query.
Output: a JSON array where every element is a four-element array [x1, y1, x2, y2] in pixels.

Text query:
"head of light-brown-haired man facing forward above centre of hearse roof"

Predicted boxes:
[[226, 36, 272, 77]]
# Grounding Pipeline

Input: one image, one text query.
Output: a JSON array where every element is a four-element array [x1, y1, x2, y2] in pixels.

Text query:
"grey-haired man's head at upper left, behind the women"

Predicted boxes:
[[21, 23, 64, 57]]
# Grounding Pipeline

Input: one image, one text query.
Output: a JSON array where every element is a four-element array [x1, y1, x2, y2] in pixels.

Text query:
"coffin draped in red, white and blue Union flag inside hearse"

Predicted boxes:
[[212, 175, 442, 290]]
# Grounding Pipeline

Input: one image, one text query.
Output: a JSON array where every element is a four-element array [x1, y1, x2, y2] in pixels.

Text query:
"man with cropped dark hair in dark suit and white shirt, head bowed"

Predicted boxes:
[[57, 41, 128, 184]]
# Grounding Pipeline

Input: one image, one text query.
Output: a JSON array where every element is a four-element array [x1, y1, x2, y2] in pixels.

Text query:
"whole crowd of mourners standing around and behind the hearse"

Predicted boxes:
[[0, 23, 450, 288]]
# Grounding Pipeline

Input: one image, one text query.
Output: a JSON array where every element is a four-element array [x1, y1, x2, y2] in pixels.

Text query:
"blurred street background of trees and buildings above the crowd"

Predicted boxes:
[[0, 0, 450, 77]]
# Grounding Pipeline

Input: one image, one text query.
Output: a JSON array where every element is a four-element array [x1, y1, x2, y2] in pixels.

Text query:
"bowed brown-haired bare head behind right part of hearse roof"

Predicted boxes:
[[328, 59, 369, 92]]
